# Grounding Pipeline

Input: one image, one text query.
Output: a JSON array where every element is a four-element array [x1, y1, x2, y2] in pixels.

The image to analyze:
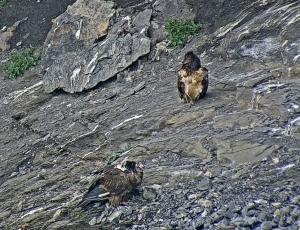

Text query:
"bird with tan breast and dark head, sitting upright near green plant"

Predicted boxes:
[[177, 51, 208, 104]]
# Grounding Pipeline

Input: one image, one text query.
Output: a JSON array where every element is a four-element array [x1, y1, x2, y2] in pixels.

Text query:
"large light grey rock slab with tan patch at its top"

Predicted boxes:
[[43, 0, 152, 93]]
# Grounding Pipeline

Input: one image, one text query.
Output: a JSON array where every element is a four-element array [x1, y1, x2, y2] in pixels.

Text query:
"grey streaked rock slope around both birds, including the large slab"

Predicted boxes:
[[0, 0, 300, 229]]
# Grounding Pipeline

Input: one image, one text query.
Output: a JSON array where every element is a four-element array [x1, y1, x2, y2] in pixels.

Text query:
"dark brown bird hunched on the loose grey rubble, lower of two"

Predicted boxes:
[[79, 159, 143, 207]]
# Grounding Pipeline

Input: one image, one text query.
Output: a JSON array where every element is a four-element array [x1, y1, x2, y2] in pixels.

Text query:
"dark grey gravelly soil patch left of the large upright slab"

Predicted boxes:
[[0, 0, 76, 49]]
